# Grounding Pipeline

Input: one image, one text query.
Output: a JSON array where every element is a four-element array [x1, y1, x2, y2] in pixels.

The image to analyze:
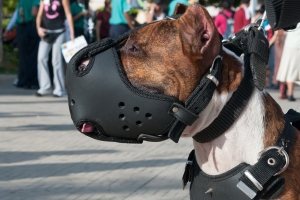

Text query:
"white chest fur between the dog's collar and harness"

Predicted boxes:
[[194, 90, 264, 175]]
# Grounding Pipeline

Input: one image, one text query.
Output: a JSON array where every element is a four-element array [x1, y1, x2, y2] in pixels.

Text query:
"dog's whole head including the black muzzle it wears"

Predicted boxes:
[[67, 5, 225, 141]]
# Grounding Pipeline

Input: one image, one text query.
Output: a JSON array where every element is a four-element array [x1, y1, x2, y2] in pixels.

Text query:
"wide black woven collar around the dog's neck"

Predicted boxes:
[[193, 24, 269, 143]]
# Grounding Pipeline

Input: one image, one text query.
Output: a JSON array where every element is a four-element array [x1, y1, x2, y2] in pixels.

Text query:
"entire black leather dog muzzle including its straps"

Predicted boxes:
[[66, 16, 222, 143]]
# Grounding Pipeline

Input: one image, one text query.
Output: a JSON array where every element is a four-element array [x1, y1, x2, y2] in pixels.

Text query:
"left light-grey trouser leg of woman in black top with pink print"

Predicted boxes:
[[37, 40, 52, 95]]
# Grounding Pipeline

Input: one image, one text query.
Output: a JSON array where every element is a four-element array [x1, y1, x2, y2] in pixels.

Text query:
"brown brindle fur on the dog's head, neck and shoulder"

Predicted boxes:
[[120, 5, 300, 200]]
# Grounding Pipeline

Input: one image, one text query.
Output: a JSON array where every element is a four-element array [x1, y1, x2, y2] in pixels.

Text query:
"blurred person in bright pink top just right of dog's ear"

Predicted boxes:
[[214, 0, 234, 39]]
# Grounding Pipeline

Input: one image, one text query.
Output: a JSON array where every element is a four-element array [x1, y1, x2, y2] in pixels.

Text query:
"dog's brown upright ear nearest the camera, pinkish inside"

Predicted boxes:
[[179, 5, 221, 67]]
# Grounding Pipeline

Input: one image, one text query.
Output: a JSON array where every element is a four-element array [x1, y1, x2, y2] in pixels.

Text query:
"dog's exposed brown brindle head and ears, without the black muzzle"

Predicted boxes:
[[120, 4, 220, 101]]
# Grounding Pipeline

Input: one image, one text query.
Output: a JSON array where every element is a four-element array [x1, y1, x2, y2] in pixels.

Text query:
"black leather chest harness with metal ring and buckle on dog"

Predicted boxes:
[[182, 109, 300, 200]]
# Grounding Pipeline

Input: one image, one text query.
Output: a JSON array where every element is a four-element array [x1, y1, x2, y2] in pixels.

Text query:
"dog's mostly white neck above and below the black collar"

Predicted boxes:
[[183, 50, 265, 175]]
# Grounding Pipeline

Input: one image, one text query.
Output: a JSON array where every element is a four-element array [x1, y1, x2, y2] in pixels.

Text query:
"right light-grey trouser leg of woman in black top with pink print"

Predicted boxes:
[[52, 33, 65, 97]]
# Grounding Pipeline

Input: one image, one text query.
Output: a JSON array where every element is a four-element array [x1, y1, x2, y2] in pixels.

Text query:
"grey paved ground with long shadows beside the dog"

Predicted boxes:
[[0, 75, 300, 200]]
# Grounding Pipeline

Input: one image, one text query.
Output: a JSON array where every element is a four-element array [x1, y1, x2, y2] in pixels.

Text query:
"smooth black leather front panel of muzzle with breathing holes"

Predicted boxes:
[[67, 43, 188, 143]]
